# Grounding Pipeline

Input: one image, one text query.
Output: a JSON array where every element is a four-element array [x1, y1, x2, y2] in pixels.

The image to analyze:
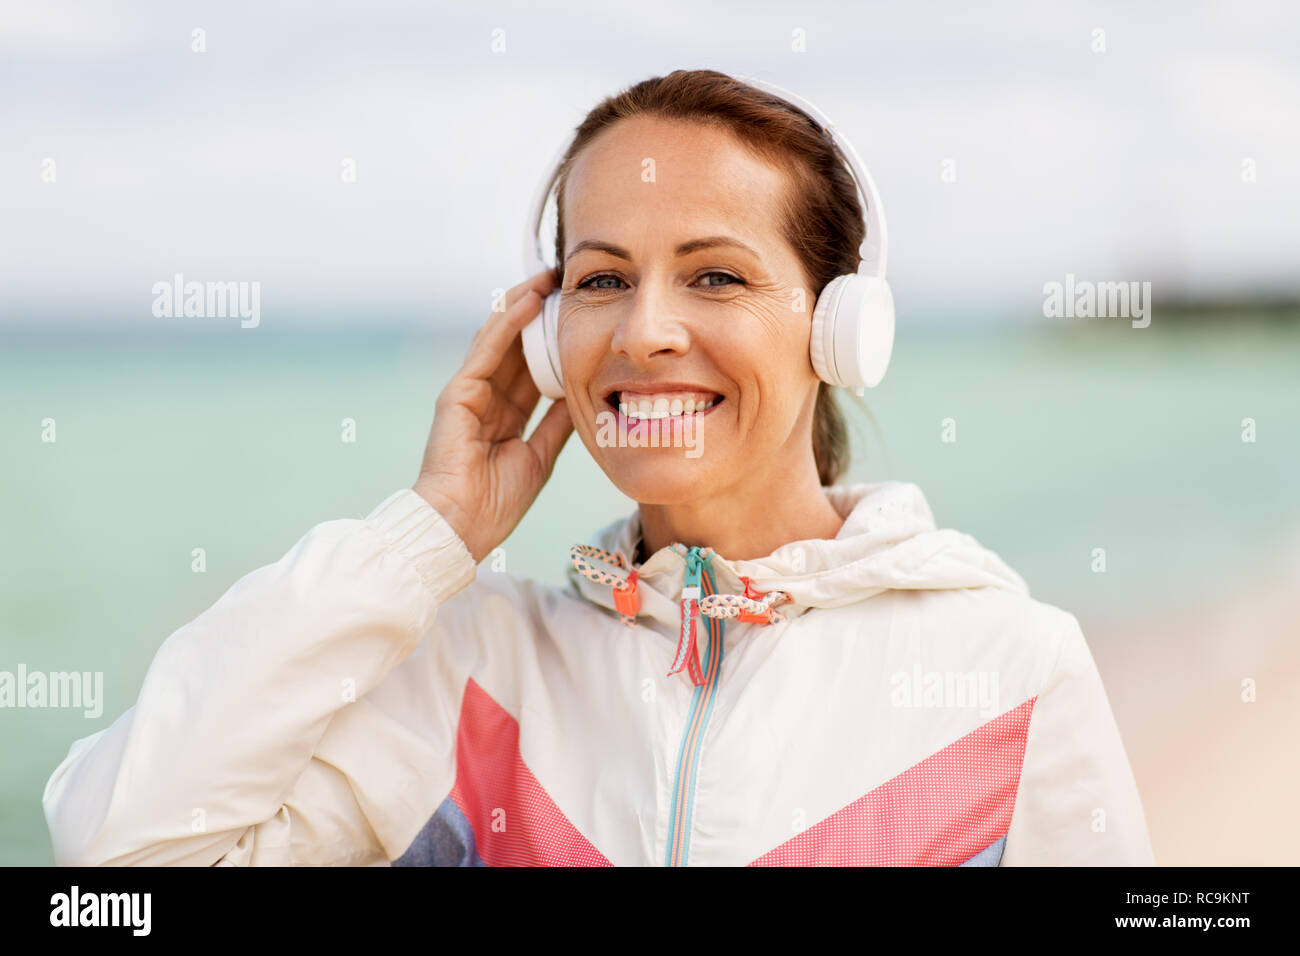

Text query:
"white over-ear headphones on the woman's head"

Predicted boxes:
[[524, 77, 894, 398]]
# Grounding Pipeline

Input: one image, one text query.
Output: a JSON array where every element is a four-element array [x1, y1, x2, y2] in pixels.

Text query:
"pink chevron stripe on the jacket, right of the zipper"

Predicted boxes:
[[750, 697, 1037, 866]]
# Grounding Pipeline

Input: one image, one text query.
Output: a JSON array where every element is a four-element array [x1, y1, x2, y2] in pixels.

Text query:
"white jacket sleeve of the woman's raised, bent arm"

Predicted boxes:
[[43, 489, 475, 865]]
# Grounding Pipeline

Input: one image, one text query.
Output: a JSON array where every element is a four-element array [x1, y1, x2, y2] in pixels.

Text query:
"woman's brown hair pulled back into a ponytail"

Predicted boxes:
[[555, 70, 866, 485]]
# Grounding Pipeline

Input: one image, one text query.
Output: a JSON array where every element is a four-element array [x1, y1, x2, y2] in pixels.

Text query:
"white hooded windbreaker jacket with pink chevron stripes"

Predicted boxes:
[[44, 481, 1153, 866]]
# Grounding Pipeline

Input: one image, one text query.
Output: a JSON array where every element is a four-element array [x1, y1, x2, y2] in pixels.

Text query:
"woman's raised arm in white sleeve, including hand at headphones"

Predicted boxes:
[[44, 272, 573, 864]]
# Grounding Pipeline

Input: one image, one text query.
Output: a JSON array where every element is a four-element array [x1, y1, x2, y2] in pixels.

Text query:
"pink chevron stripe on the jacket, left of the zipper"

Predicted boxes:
[[451, 678, 611, 866]]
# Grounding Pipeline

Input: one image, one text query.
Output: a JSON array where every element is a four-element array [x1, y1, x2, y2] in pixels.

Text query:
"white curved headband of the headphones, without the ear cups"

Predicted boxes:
[[524, 75, 888, 278]]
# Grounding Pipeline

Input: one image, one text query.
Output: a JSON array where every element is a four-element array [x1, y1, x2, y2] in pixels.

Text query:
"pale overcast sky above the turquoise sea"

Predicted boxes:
[[0, 0, 1300, 326]]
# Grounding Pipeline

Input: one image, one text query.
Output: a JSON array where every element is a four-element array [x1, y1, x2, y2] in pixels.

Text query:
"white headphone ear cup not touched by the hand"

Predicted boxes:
[[809, 274, 894, 389]]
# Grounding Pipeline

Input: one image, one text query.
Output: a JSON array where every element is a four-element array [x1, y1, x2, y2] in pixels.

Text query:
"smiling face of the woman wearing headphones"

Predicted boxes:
[[559, 117, 818, 505]]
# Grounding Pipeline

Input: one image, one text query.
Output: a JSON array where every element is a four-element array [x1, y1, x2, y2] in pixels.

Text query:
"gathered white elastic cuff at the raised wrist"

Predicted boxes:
[[365, 488, 476, 604]]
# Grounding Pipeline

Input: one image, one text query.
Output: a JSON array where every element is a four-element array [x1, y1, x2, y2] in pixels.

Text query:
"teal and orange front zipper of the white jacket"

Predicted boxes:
[[664, 548, 723, 866]]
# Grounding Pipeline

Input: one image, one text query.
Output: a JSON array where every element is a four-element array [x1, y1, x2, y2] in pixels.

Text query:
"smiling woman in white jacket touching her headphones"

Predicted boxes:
[[44, 70, 1152, 866]]
